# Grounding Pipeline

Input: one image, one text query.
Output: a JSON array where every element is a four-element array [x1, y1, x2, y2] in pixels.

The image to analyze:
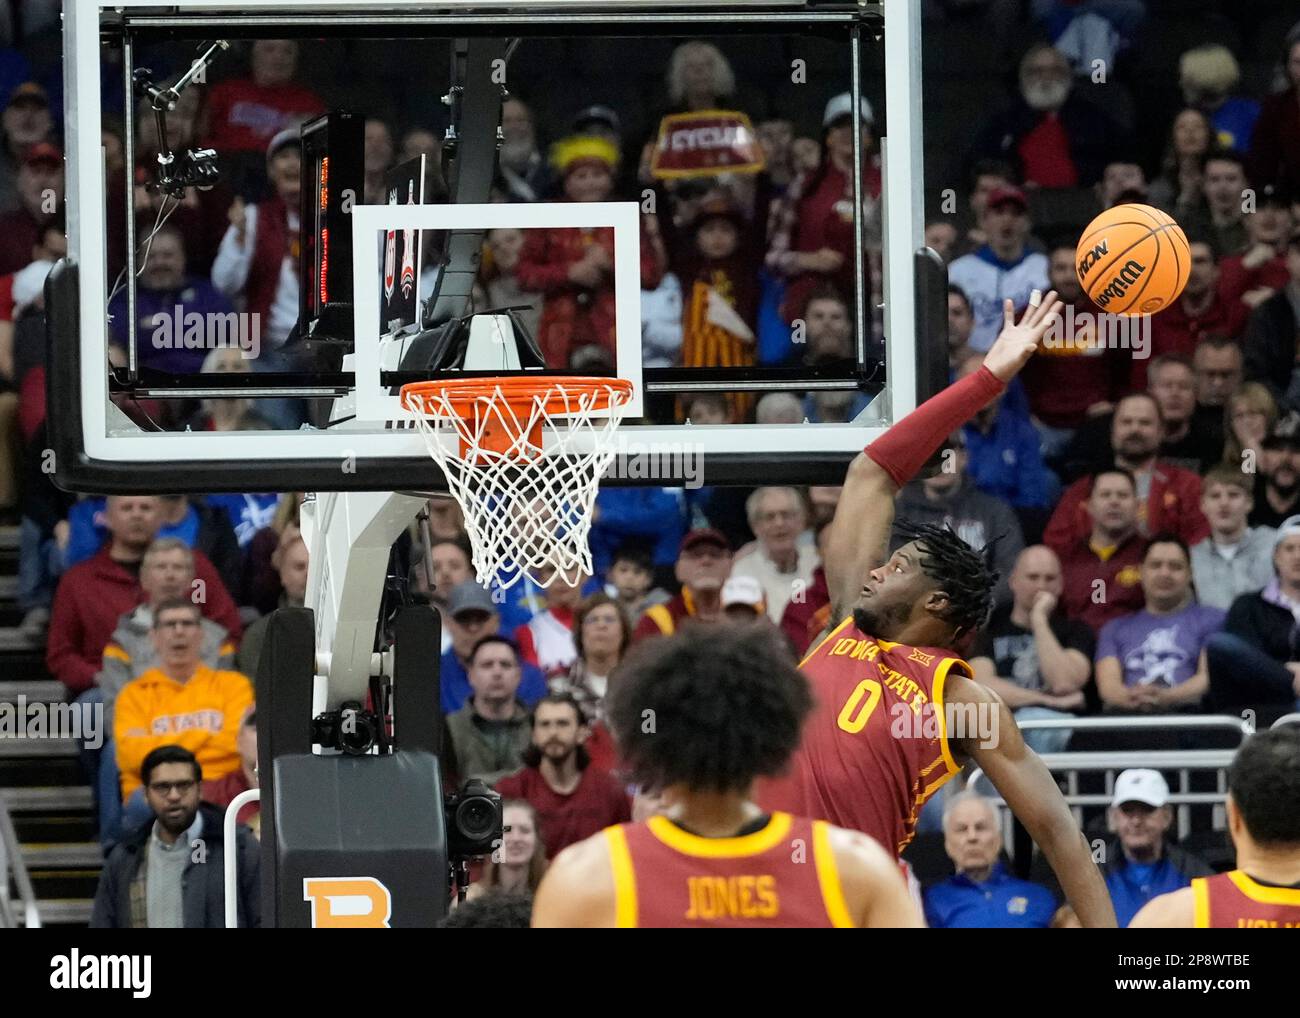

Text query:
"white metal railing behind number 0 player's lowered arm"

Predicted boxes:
[[966, 714, 1248, 850]]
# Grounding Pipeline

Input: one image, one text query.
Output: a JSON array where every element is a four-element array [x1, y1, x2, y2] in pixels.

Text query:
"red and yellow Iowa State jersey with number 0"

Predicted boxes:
[[755, 616, 972, 853]]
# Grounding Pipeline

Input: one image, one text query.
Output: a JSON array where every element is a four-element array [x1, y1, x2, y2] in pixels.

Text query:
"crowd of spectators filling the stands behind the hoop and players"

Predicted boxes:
[[0, 0, 1300, 926]]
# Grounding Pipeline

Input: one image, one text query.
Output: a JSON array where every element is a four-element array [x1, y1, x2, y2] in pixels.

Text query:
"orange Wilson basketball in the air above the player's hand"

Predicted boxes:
[[1075, 205, 1192, 315]]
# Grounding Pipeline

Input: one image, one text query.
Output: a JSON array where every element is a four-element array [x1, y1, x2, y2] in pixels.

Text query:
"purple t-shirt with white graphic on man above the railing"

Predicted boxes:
[[1097, 603, 1225, 686]]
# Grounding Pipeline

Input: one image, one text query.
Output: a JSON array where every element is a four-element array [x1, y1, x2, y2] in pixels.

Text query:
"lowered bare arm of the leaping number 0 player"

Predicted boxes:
[[944, 675, 1115, 928]]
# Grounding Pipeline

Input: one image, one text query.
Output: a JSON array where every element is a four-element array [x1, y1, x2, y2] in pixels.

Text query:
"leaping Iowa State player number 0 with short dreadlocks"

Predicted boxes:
[[755, 293, 1115, 927]]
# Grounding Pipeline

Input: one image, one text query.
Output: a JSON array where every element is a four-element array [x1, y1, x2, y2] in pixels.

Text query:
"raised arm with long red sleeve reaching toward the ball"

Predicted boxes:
[[826, 290, 1061, 623]]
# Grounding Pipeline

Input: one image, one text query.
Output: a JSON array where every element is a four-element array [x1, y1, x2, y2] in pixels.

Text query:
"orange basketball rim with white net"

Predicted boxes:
[[402, 376, 632, 589]]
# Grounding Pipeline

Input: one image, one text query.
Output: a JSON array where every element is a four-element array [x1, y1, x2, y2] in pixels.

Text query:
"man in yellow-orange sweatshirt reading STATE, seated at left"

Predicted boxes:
[[113, 599, 252, 801]]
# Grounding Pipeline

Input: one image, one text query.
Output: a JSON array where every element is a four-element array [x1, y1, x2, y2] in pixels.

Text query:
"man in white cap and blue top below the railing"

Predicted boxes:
[[1104, 768, 1214, 927]]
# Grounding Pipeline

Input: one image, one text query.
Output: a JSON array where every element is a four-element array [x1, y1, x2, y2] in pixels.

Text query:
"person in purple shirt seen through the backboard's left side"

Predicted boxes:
[[108, 225, 239, 374]]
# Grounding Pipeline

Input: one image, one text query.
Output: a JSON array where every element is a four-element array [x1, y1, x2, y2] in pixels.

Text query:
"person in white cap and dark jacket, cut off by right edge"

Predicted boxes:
[[1205, 516, 1300, 725]]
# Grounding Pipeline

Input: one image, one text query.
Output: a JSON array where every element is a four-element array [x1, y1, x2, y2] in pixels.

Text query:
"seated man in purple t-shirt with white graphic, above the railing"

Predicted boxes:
[[1097, 534, 1223, 712]]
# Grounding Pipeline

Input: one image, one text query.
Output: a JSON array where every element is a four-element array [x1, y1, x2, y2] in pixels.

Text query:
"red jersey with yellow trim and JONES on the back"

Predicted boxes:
[[605, 813, 854, 928]]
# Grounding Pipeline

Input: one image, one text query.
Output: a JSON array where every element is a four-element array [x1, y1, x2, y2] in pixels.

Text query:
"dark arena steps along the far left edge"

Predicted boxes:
[[0, 527, 103, 926]]
